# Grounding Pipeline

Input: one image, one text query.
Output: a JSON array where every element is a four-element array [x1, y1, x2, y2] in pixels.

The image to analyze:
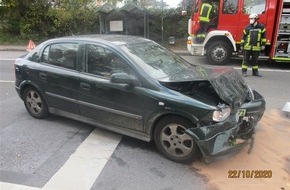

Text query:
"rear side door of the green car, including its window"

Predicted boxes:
[[38, 42, 79, 114]]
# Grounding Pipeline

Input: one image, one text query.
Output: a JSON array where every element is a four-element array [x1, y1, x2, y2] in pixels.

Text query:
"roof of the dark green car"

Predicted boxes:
[[49, 34, 151, 46]]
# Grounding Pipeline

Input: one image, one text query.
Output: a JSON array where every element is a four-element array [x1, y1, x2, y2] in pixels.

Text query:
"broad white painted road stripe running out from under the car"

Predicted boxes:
[[0, 128, 122, 190]]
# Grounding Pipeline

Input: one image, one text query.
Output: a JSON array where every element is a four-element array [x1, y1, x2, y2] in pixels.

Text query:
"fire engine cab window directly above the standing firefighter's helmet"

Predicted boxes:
[[243, 0, 266, 14]]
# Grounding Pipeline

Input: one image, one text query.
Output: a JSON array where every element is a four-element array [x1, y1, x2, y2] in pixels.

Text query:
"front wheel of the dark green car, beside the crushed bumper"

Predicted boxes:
[[154, 116, 199, 163]]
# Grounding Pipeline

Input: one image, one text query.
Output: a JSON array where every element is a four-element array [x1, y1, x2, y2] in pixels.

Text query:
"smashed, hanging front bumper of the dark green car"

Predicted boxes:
[[186, 91, 266, 163]]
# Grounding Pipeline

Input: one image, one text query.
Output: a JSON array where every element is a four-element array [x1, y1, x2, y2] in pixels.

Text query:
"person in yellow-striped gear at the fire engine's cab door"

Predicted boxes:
[[196, 2, 212, 43]]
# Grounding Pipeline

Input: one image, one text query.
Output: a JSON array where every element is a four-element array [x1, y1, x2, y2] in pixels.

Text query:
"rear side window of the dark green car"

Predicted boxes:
[[41, 43, 78, 69]]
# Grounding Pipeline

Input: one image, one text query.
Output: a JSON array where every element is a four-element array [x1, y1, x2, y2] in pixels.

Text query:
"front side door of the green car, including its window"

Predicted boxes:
[[79, 44, 144, 131]]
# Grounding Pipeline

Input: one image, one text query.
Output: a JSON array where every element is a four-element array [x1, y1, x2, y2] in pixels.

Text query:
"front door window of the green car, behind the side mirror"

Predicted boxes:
[[86, 45, 130, 78]]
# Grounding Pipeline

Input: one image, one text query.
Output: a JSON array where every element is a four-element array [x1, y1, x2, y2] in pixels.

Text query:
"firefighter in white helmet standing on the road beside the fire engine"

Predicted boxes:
[[241, 13, 266, 77]]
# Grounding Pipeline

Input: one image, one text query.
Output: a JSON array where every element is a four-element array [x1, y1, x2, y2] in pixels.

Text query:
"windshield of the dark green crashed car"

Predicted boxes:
[[122, 42, 192, 80]]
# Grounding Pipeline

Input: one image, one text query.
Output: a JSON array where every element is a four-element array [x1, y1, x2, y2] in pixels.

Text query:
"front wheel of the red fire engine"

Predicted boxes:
[[206, 41, 232, 65]]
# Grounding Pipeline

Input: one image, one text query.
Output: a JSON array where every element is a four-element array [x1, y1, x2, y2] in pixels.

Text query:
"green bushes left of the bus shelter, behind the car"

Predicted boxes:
[[0, 0, 98, 41]]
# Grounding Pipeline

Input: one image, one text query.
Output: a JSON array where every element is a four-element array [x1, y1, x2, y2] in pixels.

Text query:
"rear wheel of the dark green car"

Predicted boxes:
[[23, 87, 48, 119]]
